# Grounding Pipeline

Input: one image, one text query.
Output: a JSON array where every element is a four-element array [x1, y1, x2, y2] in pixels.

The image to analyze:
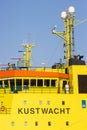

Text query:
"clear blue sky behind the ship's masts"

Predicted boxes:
[[0, 0, 87, 67]]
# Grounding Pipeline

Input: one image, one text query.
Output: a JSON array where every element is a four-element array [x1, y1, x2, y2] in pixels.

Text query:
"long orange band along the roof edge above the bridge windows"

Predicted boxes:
[[0, 70, 69, 79]]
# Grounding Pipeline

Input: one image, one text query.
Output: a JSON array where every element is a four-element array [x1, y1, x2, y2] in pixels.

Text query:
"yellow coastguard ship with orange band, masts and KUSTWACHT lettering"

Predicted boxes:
[[0, 6, 87, 130]]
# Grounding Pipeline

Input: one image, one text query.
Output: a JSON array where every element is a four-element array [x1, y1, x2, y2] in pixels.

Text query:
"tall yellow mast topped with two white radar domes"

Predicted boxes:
[[52, 6, 75, 67]]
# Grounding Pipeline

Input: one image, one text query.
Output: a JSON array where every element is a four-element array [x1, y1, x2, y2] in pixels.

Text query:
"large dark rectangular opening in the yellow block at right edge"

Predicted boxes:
[[78, 75, 87, 93]]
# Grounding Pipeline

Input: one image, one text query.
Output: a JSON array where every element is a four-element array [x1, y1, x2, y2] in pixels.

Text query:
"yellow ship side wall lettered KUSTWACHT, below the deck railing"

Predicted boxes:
[[0, 93, 87, 130]]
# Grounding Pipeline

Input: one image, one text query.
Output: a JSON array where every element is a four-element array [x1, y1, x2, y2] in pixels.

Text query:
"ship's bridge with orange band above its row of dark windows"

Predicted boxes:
[[0, 67, 69, 94]]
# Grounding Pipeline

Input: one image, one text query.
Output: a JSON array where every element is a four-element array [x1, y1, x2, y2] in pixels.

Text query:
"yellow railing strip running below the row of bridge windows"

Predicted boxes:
[[0, 87, 73, 94]]
